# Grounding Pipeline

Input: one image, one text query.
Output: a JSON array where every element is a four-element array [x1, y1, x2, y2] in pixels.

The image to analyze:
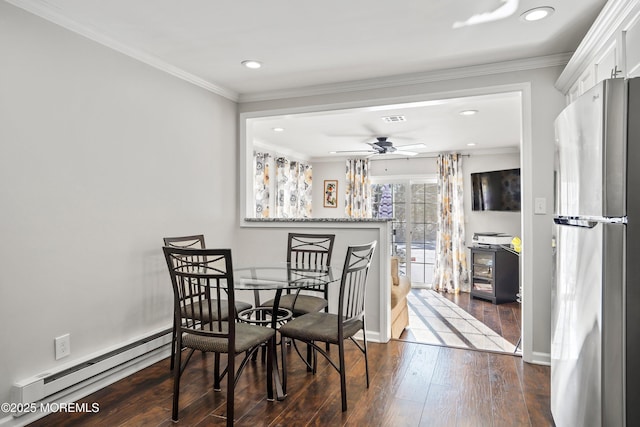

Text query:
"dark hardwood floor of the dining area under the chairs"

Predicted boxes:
[[27, 328, 553, 427]]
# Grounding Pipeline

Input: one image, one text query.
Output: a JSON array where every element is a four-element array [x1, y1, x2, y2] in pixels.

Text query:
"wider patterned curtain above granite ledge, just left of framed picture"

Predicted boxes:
[[276, 157, 312, 218]]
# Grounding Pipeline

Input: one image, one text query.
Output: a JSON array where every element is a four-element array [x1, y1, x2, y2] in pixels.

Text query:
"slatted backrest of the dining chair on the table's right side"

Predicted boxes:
[[338, 241, 377, 324]]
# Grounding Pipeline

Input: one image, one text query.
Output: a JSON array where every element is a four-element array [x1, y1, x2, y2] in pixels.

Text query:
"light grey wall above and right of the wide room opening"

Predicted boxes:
[[239, 66, 564, 363]]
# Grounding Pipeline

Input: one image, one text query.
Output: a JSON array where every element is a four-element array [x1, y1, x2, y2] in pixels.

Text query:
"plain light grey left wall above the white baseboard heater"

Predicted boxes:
[[0, 2, 237, 406]]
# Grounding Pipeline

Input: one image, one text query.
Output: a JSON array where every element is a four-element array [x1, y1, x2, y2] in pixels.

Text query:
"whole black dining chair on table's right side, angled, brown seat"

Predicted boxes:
[[279, 241, 377, 411]]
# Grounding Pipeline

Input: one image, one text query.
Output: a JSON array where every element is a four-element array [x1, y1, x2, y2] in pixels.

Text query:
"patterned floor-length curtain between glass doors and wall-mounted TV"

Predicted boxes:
[[433, 154, 469, 293]]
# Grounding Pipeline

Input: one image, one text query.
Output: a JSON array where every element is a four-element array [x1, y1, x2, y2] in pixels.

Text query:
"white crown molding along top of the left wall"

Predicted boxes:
[[5, 0, 239, 102]]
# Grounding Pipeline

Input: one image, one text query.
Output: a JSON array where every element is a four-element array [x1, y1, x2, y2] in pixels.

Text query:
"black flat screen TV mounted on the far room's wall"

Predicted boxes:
[[471, 169, 520, 212]]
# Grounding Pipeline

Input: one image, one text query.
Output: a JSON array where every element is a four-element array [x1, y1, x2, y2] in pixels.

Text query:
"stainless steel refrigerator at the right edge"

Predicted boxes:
[[551, 78, 640, 427]]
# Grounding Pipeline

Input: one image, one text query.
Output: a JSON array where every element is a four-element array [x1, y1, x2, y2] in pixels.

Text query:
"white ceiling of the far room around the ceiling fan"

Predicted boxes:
[[250, 93, 521, 160]]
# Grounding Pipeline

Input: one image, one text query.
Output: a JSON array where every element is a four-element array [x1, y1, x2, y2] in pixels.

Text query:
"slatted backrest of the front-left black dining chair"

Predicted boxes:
[[163, 246, 235, 341]]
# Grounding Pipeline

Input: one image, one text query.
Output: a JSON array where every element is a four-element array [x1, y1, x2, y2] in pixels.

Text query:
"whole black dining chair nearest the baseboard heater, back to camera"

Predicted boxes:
[[163, 246, 275, 426]]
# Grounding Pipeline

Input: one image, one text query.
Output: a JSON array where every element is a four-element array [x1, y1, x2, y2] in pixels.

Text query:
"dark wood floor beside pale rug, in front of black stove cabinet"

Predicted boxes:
[[400, 289, 522, 352]]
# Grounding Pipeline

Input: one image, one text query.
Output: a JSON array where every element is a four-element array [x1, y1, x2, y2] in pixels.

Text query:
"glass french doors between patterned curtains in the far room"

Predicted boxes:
[[373, 178, 438, 288]]
